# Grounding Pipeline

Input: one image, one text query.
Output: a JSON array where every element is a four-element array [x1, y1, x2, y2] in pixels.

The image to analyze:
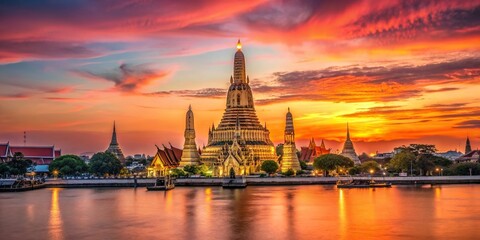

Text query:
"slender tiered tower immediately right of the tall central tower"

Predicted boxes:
[[281, 108, 301, 172]]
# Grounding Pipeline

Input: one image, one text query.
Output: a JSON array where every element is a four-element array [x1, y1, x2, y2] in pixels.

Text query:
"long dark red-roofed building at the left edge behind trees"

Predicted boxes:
[[0, 142, 62, 165]]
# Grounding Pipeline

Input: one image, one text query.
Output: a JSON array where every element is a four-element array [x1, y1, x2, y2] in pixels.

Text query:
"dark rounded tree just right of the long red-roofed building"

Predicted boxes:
[[48, 155, 88, 176]]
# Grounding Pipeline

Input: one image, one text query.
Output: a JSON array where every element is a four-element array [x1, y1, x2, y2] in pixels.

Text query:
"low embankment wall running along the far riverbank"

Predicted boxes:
[[41, 176, 480, 188]]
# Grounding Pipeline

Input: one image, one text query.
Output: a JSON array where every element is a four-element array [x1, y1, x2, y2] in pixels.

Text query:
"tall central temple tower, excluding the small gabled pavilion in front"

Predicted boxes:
[[200, 40, 278, 175]]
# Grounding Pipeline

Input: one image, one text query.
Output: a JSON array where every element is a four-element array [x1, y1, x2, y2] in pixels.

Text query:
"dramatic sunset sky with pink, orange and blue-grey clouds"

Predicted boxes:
[[0, 0, 480, 155]]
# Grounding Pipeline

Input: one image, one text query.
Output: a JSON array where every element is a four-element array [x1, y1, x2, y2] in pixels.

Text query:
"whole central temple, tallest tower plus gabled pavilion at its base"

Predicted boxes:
[[200, 40, 278, 175]]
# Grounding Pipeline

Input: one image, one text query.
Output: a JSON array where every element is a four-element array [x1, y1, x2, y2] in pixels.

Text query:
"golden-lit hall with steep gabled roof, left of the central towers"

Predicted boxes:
[[147, 145, 182, 177]]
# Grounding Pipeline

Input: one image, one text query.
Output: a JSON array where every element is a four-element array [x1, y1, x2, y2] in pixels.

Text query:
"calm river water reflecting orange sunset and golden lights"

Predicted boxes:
[[0, 185, 480, 240]]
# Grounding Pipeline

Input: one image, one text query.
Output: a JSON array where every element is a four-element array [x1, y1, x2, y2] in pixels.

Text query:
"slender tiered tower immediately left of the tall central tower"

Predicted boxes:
[[179, 105, 200, 168]]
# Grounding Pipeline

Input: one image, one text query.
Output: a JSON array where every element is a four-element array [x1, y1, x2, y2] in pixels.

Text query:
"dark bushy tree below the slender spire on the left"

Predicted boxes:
[[89, 152, 123, 176]]
